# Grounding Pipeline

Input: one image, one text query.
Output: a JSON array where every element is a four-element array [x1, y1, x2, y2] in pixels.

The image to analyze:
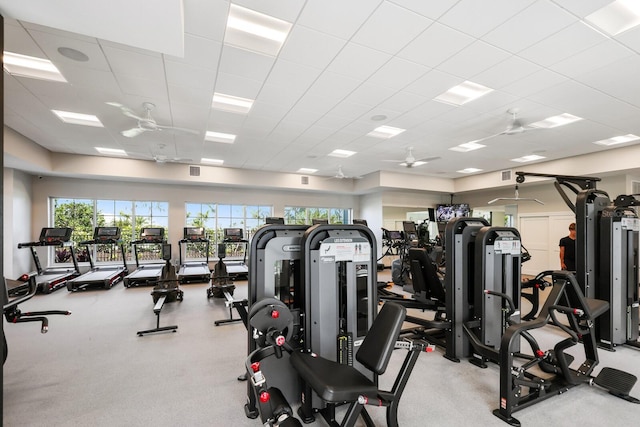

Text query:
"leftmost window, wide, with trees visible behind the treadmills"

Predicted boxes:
[[52, 198, 169, 262]]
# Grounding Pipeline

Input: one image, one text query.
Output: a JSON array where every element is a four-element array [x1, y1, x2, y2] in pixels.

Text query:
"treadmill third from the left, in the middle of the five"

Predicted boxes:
[[123, 227, 166, 288]]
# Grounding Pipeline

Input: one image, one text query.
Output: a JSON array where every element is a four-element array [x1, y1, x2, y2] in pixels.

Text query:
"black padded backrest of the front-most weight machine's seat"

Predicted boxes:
[[356, 302, 407, 375]]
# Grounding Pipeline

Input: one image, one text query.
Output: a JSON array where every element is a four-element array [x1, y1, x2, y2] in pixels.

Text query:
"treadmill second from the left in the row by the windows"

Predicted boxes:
[[67, 227, 129, 292]]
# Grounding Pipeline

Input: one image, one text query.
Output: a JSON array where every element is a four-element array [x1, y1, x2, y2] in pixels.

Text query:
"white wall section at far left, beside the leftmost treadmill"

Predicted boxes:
[[2, 168, 33, 279]]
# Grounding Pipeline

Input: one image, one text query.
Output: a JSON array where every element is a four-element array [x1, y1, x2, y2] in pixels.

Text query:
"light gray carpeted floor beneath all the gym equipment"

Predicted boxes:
[[3, 276, 640, 427]]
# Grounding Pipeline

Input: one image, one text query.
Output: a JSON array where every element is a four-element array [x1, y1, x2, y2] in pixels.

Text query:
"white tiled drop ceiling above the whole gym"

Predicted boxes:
[[0, 0, 640, 182]]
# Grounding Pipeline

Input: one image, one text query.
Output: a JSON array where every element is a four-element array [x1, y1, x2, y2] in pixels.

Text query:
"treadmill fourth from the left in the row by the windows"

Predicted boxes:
[[178, 227, 211, 283]]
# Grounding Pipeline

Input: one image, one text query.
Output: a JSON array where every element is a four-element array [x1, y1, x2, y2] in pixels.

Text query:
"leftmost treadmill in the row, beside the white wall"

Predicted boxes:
[[15, 227, 80, 296]]
